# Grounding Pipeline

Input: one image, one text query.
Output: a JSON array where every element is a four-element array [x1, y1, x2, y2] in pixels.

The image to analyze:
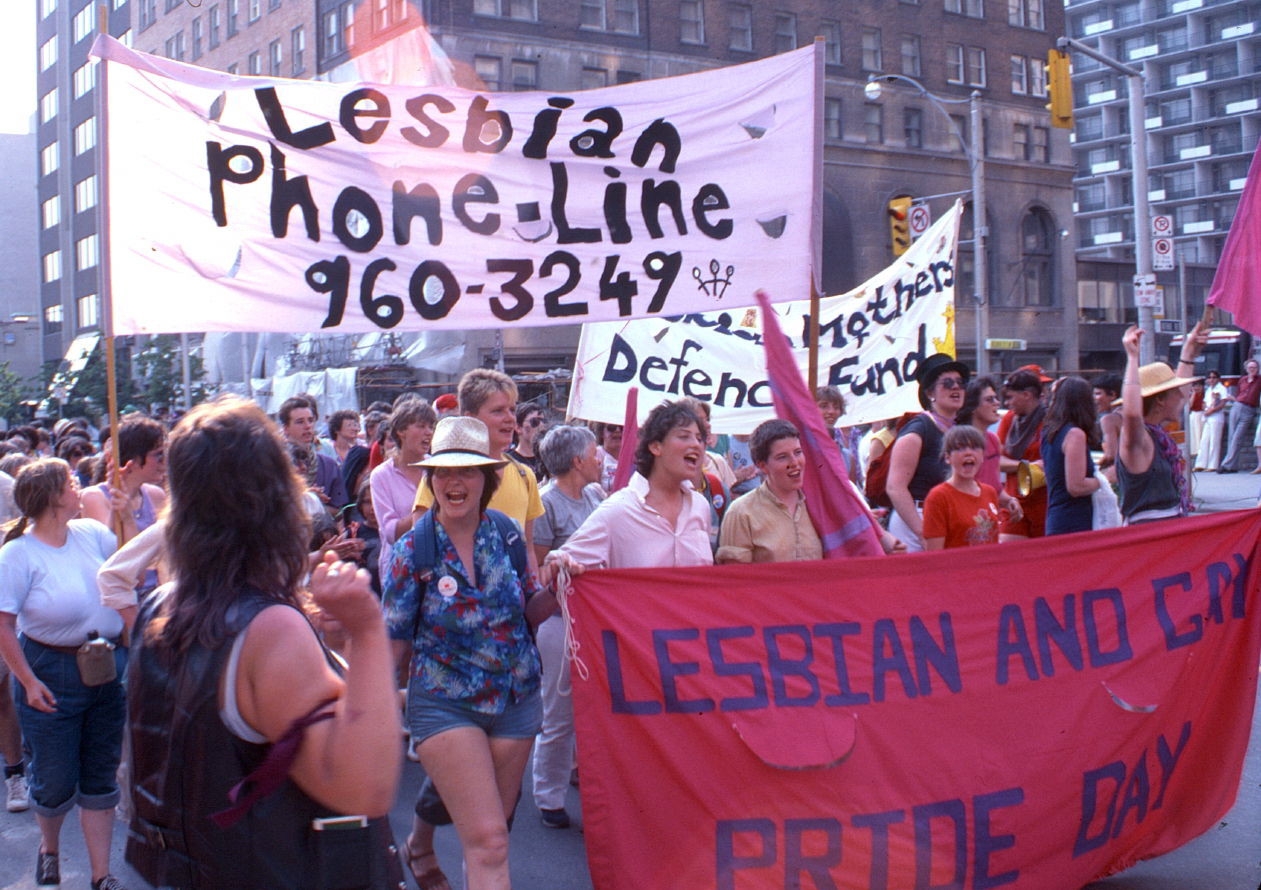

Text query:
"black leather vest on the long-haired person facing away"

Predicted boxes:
[[126, 592, 397, 890]]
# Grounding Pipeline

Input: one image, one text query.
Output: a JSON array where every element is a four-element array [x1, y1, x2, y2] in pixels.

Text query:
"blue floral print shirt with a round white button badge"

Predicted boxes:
[[381, 516, 540, 714]]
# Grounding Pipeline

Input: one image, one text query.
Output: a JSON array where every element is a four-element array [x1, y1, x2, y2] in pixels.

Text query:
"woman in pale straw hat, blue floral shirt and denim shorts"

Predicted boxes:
[[382, 417, 555, 890]]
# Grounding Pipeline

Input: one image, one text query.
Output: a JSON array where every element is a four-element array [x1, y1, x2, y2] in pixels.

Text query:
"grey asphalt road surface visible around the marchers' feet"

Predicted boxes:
[[0, 473, 1261, 890]]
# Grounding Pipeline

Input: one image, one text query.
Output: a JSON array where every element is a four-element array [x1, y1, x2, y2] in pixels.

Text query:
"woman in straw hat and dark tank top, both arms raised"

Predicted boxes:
[[1116, 324, 1208, 526]]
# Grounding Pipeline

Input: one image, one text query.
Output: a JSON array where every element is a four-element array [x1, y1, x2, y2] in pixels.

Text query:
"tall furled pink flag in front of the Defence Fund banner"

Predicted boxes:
[[751, 290, 884, 560]]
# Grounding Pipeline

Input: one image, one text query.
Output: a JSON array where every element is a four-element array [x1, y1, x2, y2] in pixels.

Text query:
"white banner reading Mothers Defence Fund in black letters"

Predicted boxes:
[[569, 197, 961, 432]]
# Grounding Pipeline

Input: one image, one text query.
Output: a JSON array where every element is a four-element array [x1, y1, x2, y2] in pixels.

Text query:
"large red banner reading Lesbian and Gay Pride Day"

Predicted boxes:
[[570, 511, 1261, 890]]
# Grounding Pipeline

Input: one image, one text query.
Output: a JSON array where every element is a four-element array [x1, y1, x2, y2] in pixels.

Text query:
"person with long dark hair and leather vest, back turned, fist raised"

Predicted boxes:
[[127, 397, 402, 890]]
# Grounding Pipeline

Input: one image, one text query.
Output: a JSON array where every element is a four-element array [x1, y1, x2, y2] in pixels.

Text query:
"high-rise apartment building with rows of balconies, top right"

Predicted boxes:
[[1067, 0, 1261, 368]]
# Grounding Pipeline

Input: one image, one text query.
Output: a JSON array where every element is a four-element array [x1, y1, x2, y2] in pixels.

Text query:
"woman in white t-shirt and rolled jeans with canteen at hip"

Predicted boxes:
[[0, 458, 126, 890]]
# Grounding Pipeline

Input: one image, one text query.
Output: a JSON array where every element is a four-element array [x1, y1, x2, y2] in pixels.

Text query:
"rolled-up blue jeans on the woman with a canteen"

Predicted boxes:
[[13, 637, 127, 817]]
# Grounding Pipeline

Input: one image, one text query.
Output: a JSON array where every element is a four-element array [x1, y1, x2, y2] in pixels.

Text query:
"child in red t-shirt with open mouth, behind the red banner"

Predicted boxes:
[[924, 425, 999, 550]]
